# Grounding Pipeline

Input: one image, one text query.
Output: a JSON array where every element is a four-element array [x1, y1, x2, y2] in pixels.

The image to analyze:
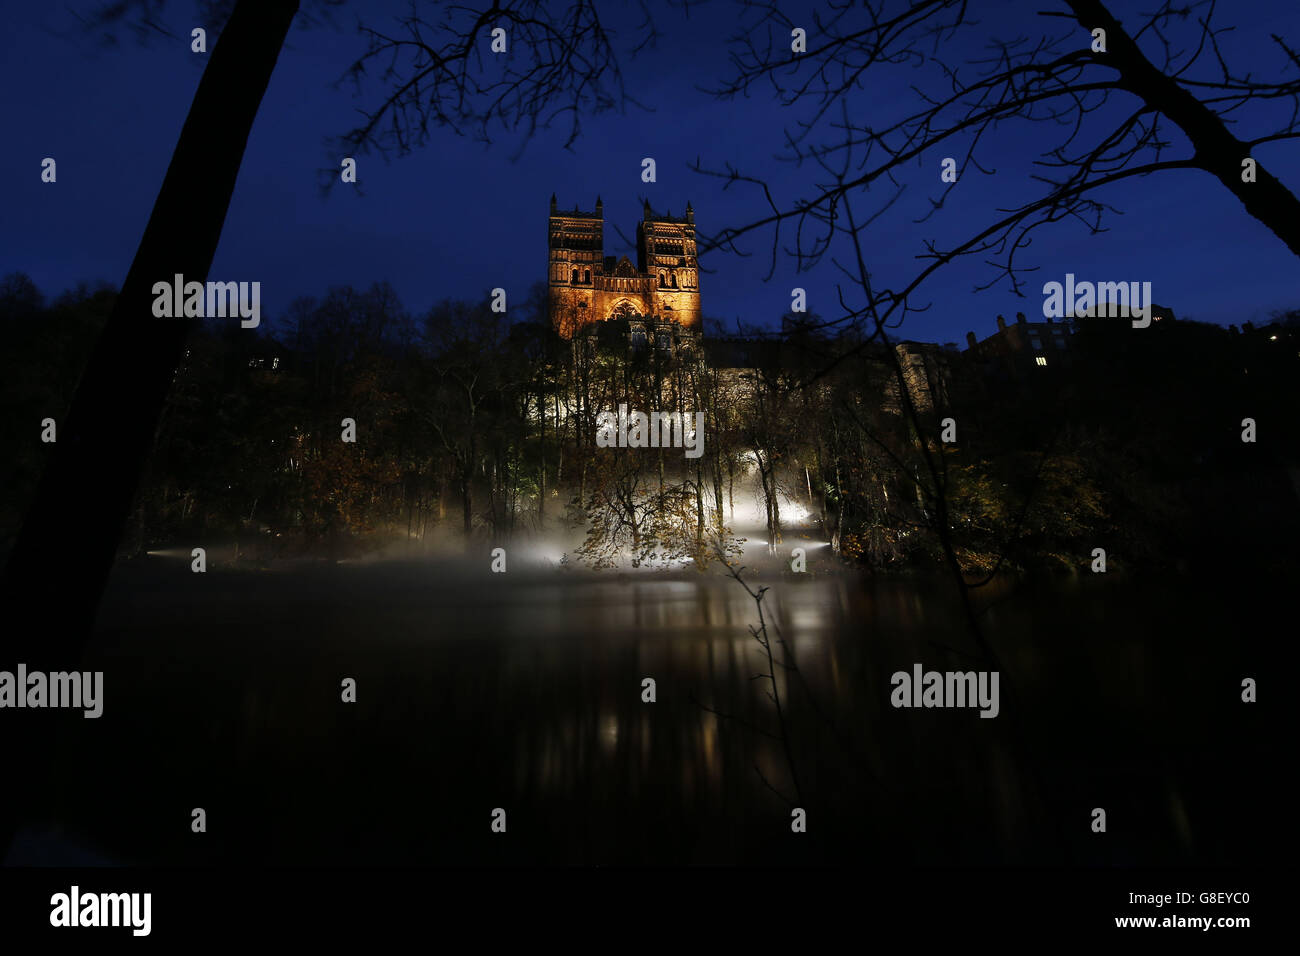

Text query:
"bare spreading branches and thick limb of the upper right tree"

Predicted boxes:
[[696, 0, 1300, 328]]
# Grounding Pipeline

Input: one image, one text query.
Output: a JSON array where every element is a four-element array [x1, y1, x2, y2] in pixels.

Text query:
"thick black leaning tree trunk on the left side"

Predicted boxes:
[[0, 0, 298, 857]]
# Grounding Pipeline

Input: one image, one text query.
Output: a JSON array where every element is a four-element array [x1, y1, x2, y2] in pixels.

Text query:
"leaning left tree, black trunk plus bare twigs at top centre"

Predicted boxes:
[[0, 0, 653, 848]]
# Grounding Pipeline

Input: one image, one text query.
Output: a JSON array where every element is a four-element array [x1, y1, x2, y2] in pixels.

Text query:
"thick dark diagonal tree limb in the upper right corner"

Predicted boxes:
[[1067, 0, 1300, 256]]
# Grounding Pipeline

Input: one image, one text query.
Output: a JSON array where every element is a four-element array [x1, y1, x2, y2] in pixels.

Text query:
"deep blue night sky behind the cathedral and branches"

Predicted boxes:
[[0, 0, 1300, 342]]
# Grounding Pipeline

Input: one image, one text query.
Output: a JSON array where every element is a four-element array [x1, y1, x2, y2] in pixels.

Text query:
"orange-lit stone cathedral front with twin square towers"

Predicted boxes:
[[547, 195, 699, 338]]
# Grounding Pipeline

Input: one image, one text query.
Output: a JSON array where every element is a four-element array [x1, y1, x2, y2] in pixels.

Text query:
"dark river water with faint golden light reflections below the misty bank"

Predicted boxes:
[[10, 562, 1283, 865]]
